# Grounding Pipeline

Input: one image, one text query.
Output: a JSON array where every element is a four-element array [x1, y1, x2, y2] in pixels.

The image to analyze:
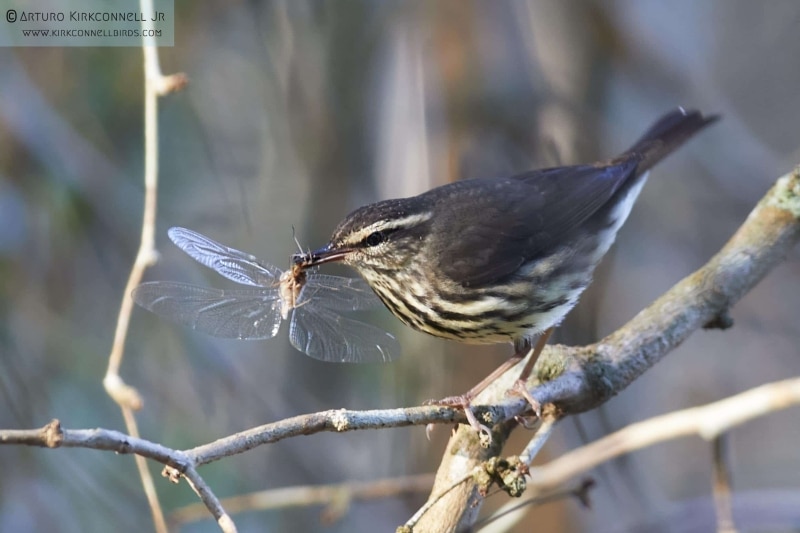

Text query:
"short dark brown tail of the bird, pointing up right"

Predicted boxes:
[[619, 107, 719, 174]]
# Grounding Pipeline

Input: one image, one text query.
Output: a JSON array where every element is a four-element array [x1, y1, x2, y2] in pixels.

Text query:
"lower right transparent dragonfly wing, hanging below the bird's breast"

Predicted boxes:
[[289, 286, 400, 363]]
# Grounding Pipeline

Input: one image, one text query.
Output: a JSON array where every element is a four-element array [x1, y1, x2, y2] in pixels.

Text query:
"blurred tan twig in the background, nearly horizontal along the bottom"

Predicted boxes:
[[170, 474, 433, 524]]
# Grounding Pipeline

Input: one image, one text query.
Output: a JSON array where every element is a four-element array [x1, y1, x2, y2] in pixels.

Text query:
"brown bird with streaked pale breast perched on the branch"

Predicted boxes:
[[295, 109, 717, 428]]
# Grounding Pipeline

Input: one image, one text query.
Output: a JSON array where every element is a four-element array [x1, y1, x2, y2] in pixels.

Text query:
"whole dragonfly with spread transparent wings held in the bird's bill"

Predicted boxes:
[[133, 227, 400, 363]]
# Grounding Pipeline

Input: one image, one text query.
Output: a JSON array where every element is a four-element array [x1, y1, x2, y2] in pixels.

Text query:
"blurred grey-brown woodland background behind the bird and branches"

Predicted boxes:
[[0, 0, 800, 532]]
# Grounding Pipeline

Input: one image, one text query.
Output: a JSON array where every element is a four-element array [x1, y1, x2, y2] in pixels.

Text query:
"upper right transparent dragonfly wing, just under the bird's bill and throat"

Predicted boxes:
[[298, 274, 382, 311]]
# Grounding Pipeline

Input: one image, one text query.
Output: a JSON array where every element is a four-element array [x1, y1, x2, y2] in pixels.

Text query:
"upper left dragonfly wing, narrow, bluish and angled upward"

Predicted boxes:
[[167, 227, 281, 287]]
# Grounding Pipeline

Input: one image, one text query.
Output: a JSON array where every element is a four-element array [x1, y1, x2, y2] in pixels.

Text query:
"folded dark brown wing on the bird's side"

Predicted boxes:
[[431, 160, 638, 287]]
